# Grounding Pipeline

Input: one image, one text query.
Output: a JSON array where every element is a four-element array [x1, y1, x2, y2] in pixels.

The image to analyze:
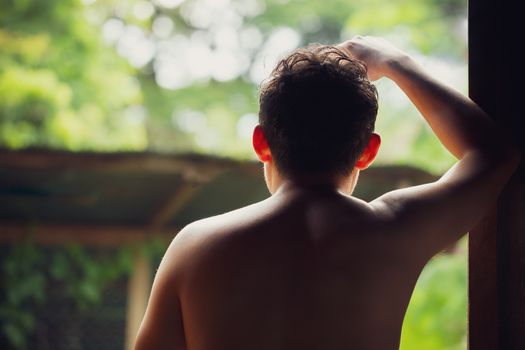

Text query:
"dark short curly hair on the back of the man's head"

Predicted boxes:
[[259, 44, 378, 176]]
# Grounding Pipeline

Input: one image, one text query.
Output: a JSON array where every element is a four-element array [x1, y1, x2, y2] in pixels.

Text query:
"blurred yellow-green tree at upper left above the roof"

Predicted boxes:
[[0, 0, 147, 149]]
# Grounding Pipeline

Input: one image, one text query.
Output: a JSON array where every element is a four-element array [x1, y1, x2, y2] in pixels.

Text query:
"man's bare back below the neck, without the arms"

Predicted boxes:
[[173, 188, 425, 349]]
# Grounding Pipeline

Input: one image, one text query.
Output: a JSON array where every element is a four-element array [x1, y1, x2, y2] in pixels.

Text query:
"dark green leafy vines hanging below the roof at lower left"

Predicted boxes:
[[0, 240, 166, 349]]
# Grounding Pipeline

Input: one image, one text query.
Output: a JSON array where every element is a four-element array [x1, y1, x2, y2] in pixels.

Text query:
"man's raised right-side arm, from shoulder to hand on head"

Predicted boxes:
[[340, 37, 519, 258]]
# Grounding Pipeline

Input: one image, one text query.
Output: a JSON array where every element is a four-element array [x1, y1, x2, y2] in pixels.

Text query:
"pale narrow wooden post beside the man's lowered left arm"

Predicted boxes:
[[125, 253, 151, 350]]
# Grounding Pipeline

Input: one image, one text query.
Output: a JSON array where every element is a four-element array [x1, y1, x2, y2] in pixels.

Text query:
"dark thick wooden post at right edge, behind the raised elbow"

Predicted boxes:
[[469, 0, 525, 350]]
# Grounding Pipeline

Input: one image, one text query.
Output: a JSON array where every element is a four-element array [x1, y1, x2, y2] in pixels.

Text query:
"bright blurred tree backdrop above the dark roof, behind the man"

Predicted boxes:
[[0, 0, 466, 171]]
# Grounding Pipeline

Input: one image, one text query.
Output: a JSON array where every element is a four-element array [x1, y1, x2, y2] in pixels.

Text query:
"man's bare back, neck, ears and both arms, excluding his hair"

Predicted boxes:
[[136, 38, 518, 350]]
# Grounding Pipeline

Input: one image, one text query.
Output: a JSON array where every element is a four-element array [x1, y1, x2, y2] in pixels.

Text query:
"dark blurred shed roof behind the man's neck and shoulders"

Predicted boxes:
[[0, 150, 435, 243]]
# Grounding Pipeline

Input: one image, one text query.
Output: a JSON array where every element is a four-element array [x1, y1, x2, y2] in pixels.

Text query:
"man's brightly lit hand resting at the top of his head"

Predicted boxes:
[[337, 36, 407, 81]]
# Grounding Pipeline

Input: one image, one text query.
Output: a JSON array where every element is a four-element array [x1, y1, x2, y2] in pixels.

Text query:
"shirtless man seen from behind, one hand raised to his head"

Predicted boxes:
[[135, 37, 519, 350]]
